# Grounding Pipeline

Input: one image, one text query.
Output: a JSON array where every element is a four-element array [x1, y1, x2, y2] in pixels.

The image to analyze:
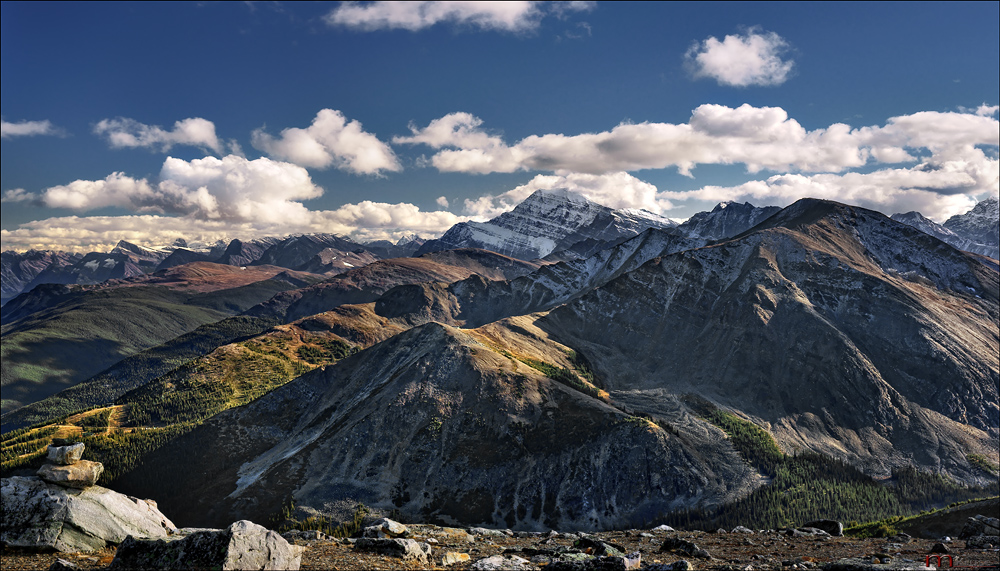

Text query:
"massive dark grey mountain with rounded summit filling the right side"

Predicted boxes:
[[539, 200, 1000, 481]]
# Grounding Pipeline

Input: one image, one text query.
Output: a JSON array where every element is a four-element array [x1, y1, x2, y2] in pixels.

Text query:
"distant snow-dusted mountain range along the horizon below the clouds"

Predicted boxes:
[[0, 194, 1000, 305]]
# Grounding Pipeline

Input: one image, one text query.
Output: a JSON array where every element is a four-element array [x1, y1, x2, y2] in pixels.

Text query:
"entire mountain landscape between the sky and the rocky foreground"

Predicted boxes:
[[2, 190, 1000, 530]]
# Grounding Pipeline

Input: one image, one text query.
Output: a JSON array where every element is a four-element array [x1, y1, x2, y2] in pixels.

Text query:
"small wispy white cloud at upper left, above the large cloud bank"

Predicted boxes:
[[94, 117, 223, 155]]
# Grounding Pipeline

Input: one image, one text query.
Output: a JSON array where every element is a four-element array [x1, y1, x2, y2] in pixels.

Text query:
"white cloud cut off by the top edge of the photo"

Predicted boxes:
[[325, 2, 594, 32]]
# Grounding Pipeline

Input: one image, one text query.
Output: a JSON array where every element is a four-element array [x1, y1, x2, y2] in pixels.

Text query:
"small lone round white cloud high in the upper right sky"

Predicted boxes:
[[684, 29, 794, 87]]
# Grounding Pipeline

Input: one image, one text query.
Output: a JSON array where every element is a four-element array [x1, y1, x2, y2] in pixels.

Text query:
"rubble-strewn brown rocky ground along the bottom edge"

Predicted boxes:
[[0, 523, 998, 571]]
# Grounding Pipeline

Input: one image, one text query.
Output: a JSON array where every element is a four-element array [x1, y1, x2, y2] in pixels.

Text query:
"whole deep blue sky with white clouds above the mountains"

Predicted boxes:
[[0, 2, 1000, 251]]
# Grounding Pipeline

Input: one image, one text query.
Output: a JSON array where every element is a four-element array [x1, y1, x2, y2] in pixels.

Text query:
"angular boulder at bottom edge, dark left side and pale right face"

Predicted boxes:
[[109, 520, 305, 571]]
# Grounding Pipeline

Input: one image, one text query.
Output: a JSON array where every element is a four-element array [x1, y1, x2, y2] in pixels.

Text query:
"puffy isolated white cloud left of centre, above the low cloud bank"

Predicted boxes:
[[252, 109, 402, 174]]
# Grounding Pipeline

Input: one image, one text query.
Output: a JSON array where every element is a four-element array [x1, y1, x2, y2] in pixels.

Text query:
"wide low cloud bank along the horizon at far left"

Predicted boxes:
[[2, 155, 469, 251]]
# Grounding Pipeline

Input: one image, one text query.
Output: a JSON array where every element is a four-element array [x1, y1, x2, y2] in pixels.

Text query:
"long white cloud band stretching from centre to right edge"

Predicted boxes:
[[393, 104, 1000, 175]]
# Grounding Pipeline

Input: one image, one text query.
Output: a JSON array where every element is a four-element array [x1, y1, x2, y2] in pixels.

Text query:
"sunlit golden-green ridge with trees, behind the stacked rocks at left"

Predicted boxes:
[[0, 328, 357, 485]]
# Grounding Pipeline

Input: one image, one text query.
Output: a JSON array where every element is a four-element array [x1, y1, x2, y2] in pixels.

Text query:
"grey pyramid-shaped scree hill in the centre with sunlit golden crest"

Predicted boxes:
[[119, 323, 756, 529]]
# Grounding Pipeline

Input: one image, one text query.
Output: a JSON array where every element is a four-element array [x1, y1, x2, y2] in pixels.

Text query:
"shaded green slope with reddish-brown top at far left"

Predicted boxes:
[[0, 263, 304, 416]]
